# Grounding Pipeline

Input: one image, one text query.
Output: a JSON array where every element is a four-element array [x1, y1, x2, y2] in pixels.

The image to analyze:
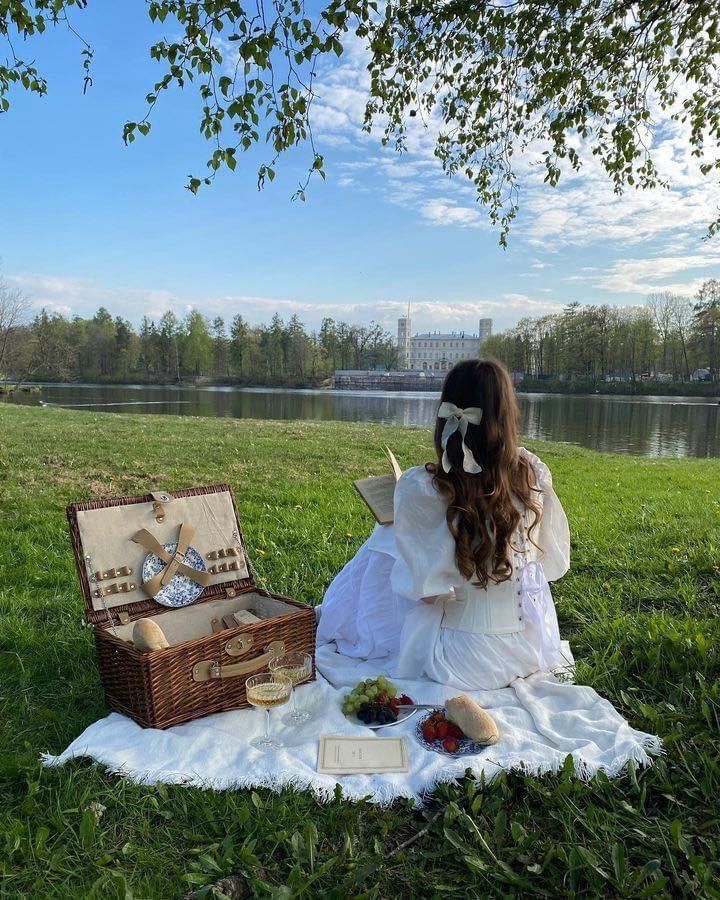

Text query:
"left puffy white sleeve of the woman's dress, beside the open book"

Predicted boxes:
[[390, 466, 462, 600]]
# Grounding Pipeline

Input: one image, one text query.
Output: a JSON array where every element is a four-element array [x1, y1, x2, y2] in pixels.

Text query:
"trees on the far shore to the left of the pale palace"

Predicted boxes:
[[0, 298, 397, 386]]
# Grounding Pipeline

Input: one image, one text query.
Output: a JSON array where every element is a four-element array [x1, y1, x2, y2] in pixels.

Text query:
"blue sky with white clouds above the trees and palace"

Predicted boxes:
[[0, 0, 720, 338]]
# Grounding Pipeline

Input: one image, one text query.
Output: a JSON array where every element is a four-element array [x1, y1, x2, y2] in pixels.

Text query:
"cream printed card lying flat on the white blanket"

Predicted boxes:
[[317, 734, 410, 775]]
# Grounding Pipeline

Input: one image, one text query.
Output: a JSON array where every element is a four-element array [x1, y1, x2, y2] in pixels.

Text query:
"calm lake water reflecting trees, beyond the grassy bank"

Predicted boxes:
[[7, 384, 720, 457]]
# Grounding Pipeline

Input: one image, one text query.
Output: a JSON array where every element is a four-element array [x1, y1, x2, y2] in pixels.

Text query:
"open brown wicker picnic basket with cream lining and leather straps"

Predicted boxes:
[[67, 484, 316, 728]]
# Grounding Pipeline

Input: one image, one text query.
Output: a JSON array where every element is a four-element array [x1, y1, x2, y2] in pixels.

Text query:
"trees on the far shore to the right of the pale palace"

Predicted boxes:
[[482, 279, 720, 382]]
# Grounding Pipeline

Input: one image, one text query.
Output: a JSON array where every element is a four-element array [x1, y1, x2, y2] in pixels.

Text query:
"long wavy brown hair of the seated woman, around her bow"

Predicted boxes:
[[426, 359, 542, 588]]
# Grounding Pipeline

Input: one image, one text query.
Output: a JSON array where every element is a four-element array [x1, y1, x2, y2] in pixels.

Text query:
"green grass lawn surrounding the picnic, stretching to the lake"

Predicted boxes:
[[0, 406, 720, 898]]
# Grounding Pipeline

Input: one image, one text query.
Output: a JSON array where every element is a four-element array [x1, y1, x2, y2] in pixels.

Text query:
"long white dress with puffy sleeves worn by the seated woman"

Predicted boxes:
[[317, 448, 573, 690]]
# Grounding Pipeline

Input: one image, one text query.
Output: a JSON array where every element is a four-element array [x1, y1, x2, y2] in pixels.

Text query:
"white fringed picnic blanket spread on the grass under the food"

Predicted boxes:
[[43, 646, 661, 804]]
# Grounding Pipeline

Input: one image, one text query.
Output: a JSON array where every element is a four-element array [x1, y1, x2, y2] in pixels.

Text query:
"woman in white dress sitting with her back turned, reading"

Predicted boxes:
[[318, 360, 573, 690]]
